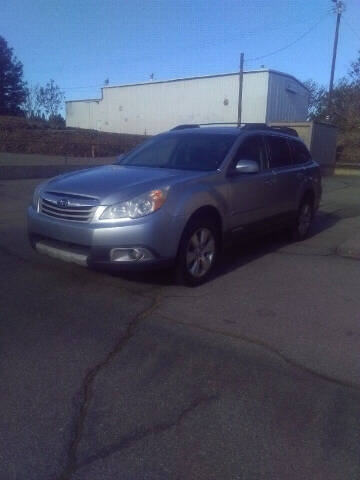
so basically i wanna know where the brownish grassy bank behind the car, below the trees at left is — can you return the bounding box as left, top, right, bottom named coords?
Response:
left=0, top=116, right=145, bottom=157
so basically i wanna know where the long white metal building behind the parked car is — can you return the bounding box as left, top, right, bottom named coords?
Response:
left=66, top=70, right=309, bottom=135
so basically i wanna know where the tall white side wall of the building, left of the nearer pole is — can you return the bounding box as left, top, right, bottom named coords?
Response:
left=103, top=76, right=237, bottom=135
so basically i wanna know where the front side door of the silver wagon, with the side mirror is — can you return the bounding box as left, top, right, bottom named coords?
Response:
left=228, top=134, right=276, bottom=231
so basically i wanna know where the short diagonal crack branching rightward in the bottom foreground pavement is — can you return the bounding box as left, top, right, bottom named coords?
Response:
left=77, top=395, right=218, bottom=469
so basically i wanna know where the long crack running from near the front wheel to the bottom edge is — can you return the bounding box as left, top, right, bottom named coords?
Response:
left=59, top=294, right=160, bottom=480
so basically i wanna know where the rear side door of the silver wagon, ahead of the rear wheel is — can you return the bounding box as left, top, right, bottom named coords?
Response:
left=265, top=134, right=303, bottom=222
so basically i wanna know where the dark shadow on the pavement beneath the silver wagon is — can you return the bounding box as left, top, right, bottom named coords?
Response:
left=97, top=211, right=342, bottom=288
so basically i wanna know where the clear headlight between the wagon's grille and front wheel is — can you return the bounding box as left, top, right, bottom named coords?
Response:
left=100, top=187, right=169, bottom=220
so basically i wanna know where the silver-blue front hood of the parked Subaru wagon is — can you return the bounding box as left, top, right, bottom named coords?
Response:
left=43, top=165, right=209, bottom=205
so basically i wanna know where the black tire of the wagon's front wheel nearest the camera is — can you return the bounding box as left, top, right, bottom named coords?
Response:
left=175, top=217, right=220, bottom=286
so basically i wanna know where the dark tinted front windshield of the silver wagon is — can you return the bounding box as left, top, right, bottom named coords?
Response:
left=118, top=133, right=236, bottom=171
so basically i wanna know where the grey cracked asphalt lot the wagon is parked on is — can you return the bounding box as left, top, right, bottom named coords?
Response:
left=0, top=177, right=360, bottom=480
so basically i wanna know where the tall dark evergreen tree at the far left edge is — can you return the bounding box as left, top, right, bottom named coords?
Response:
left=0, top=36, right=27, bottom=115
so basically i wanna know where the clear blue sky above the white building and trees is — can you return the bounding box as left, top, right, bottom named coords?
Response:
left=0, top=0, right=360, bottom=100
